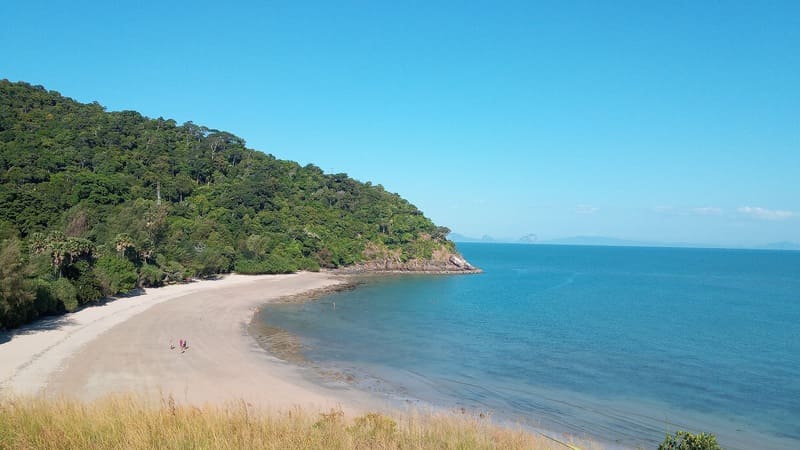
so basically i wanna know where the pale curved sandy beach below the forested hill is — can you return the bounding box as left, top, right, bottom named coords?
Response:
left=0, top=273, right=374, bottom=411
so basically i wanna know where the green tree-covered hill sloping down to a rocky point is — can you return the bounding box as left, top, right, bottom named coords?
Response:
left=0, top=80, right=472, bottom=328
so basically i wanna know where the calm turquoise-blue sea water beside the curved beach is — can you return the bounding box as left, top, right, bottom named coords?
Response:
left=259, top=244, right=800, bottom=449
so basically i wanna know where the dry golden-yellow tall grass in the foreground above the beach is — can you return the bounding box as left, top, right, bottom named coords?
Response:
left=0, top=396, right=588, bottom=450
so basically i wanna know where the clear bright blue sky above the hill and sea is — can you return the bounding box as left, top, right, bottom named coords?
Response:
left=0, top=0, right=800, bottom=246
